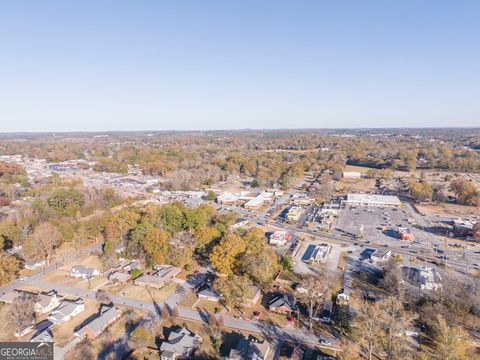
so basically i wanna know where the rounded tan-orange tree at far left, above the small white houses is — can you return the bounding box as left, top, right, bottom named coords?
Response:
left=25, top=222, right=63, bottom=264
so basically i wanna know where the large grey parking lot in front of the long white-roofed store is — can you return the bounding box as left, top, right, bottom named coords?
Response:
left=336, top=206, right=428, bottom=245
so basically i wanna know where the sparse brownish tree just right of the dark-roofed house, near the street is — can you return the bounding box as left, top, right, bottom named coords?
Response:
left=299, top=269, right=332, bottom=330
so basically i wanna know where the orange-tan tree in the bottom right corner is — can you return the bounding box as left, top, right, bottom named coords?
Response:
left=434, top=315, right=467, bottom=360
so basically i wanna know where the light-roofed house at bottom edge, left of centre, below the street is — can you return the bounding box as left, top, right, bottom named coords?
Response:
left=160, top=327, right=202, bottom=360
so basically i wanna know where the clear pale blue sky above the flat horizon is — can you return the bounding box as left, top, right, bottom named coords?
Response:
left=0, top=0, right=480, bottom=132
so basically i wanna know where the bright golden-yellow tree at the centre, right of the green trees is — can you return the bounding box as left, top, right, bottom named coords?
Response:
left=210, top=233, right=246, bottom=275
